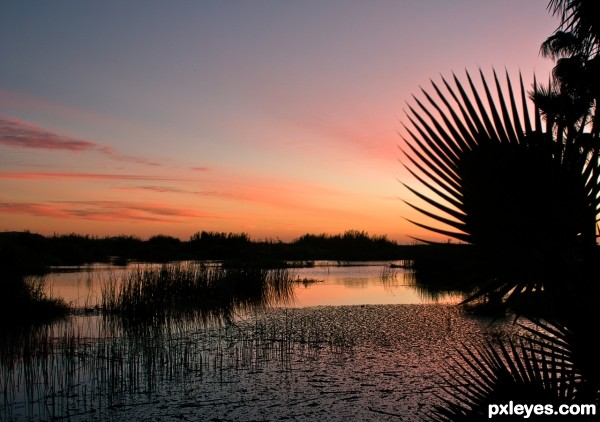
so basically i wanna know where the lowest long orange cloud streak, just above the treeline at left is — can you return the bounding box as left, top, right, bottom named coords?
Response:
left=0, top=201, right=222, bottom=223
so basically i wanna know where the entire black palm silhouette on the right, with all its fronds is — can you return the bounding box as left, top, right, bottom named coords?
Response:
left=402, top=0, right=600, bottom=421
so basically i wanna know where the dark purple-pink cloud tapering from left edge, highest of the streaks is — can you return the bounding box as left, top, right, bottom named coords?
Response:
left=0, top=116, right=162, bottom=166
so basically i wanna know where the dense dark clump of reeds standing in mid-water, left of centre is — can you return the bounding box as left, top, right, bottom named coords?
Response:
left=101, top=262, right=297, bottom=321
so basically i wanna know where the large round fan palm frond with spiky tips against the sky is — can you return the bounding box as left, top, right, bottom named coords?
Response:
left=401, top=71, right=598, bottom=306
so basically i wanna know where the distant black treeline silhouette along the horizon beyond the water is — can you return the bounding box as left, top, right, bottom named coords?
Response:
left=0, top=230, right=432, bottom=272
